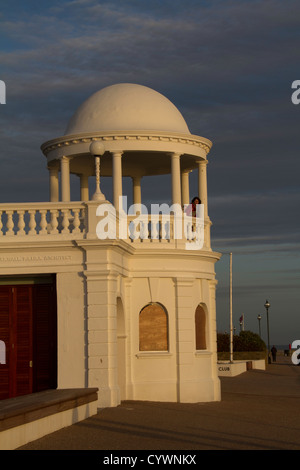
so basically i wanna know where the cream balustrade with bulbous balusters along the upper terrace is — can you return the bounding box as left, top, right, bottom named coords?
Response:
left=0, top=201, right=210, bottom=249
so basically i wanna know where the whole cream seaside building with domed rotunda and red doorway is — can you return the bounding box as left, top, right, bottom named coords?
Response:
left=0, top=84, right=220, bottom=407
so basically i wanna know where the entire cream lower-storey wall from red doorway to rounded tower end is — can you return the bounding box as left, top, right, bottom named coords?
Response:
left=2, top=240, right=220, bottom=406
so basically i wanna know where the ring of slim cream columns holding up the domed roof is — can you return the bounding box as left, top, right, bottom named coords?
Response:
left=49, top=152, right=208, bottom=216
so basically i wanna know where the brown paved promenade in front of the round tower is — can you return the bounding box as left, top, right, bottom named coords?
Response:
left=21, top=356, right=300, bottom=451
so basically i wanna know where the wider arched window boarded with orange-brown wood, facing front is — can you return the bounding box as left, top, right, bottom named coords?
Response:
left=139, top=303, right=169, bottom=351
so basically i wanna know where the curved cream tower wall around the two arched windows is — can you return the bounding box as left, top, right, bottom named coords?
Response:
left=128, top=266, right=220, bottom=402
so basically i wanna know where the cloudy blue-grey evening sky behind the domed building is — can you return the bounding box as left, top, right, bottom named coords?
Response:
left=0, top=0, right=300, bottom=345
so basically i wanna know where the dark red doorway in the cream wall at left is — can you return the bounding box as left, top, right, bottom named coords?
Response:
left=0, top=276, right=57, bottom=400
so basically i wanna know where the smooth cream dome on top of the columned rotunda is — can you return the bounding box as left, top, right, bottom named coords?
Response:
left=65, top=83, right=190, bottom=135
